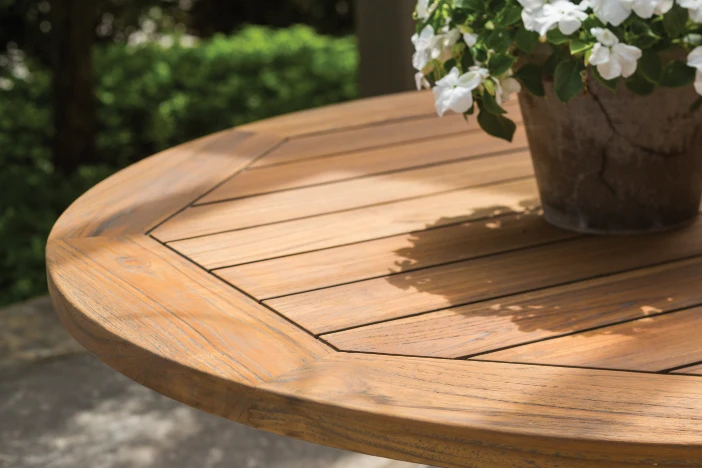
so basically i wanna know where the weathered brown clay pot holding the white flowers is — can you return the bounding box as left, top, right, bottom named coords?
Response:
left=520, top=77, right=702, bottom=234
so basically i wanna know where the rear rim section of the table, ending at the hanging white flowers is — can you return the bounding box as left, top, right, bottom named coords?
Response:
left=238, top=91, right=436, bottom=137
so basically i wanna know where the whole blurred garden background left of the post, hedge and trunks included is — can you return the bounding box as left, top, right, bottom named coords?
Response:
left=0, top=0, right=358, bottom=305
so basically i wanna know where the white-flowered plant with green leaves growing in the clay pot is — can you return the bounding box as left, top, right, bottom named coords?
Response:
left=412, top=0, right=702, bottom=141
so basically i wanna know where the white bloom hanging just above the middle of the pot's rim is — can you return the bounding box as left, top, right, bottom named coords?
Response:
left=590, top=28, right=642, bottom=80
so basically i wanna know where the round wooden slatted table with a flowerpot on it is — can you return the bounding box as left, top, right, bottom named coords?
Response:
left=47, top=93, right=702, bottom=468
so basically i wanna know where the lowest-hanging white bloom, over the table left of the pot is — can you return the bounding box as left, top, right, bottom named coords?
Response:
left=433, top=67, right=488, bottom=116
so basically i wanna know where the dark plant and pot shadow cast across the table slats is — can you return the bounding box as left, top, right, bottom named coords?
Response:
left=381, top=210, right=702, bottom=367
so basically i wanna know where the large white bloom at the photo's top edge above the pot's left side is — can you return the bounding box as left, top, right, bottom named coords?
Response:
left=519, top=0, right=589, bottom=36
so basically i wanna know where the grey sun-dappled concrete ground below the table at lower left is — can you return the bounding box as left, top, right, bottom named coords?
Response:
left=0, top=298, right=428, bottom=468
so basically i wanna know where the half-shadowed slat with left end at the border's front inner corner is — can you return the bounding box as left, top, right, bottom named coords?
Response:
left=324, top=259, right=702, bottom=358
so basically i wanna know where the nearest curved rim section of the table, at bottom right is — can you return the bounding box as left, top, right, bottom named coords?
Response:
left=245, top=354, right=702, bottom=468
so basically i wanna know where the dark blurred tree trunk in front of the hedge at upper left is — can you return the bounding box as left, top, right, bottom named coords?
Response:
left=51, top=0, right=98, bottom=174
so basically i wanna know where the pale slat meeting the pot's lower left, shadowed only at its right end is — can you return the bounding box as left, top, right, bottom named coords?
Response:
left=170, top=179, right=538, bottom=269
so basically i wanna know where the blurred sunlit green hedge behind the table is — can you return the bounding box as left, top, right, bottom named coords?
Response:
left=0, top=26, right=357, bottom=304
